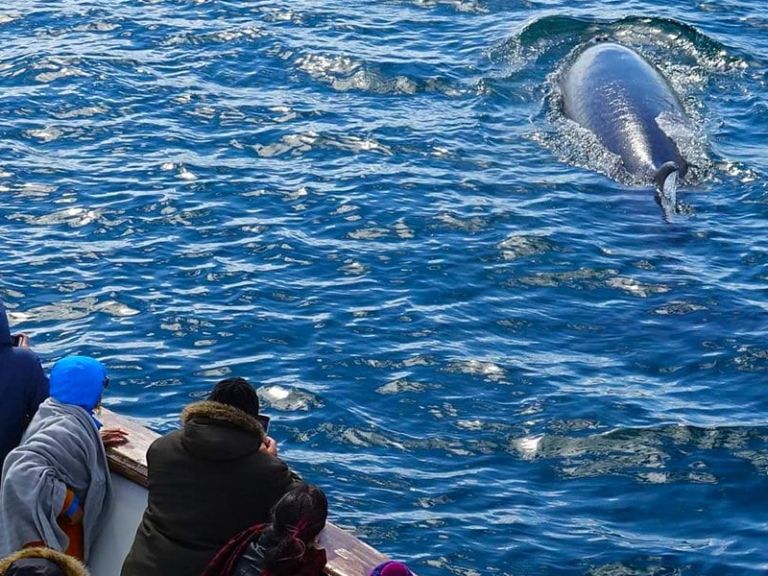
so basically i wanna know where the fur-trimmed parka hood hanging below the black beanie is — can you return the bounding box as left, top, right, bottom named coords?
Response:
left=181, top=400, right=265, bottom=460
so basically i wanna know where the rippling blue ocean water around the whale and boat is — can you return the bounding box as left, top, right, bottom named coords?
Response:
left=0, top=0, right=768, bottom=576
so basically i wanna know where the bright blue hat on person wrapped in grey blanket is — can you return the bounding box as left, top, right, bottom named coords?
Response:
left=50, top=356, right=108, bottom=412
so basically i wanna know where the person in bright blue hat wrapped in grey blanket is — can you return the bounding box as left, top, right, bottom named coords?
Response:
left=0, top=356, right=126, bottom=560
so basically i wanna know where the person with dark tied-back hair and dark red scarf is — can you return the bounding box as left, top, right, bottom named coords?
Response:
left=201, top=484, right=328, bottom=576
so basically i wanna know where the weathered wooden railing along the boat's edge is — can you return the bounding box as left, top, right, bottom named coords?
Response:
left=100, top=409, right=387, bottom=576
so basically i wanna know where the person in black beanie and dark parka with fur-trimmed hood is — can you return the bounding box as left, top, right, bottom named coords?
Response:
left=121, top=378, right=301, bottom=576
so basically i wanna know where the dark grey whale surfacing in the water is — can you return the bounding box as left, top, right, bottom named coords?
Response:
left=559, top=37, right=690, bottom=216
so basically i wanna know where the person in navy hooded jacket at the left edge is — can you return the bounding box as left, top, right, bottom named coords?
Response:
left=0, top=301, right=48, bottom=467
